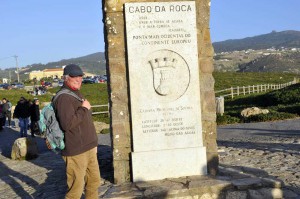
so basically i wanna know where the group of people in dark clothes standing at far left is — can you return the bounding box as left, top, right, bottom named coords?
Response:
left=0, top=97, right=40, bottom=137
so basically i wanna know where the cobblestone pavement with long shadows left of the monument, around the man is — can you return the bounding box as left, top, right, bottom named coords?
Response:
left=0, top=128, right=112, bottom=199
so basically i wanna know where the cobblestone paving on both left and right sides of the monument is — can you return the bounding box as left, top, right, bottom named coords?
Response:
left=0, top=119, right=300, bottom=199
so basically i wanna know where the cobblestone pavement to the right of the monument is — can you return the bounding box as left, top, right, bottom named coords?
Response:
left=218, top=119, right=300, bottom=195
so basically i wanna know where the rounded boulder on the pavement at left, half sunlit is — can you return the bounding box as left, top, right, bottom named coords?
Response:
left=11, top=138, right=38, bottom=160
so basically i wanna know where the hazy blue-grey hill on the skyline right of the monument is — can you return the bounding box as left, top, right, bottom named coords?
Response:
left=213, top=30, right=300, bottom=53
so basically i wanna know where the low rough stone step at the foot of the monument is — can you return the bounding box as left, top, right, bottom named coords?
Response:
left=101, top=167, right=298, bottom=199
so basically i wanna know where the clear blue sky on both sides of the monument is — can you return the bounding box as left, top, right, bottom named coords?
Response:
left=0, top=0, right=300, bottom=69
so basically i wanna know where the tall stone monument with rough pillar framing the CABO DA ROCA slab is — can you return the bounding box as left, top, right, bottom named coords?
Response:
left=104, top=0, right=218, bottom=184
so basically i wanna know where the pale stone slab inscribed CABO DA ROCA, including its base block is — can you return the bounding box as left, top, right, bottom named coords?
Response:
left=125, top=1, right=206, bottom=181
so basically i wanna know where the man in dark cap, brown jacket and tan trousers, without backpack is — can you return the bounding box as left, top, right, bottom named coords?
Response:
left=54, top=64, right=101, bottom=199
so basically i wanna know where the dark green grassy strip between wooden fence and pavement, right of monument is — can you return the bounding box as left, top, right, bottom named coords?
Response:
left=217, top=83, right=300, bottom=124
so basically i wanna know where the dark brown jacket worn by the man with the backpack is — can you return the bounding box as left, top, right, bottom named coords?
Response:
left=54, top=85, right=98, bottom=156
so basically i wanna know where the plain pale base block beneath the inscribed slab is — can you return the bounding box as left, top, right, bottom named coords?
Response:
left=131, top=147, right=207, bottom=182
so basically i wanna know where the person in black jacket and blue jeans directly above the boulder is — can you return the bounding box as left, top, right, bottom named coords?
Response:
left=13, top=97, right=30, bottom=137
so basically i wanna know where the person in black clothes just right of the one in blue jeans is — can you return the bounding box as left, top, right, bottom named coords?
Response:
left=29, top=98, right=40, bottom=137
